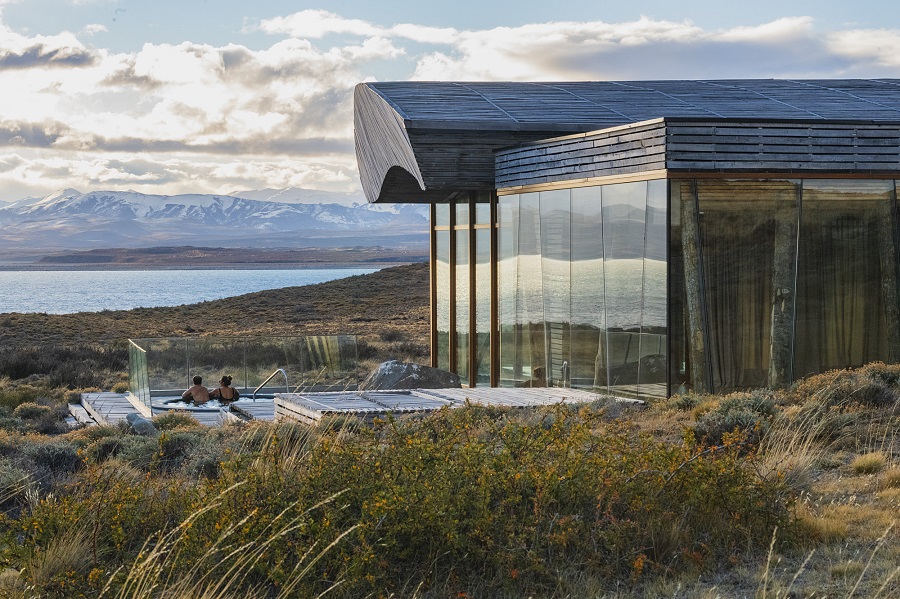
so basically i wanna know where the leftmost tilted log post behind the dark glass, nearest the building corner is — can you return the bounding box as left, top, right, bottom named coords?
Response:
left=681, top=182, right=713, bottom=393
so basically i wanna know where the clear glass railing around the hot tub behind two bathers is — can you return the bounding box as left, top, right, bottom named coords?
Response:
left=129, top=335, right=364, bottom=404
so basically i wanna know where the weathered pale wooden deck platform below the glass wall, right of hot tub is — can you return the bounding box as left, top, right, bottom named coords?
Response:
left=275, top=387, right=628, bottom=424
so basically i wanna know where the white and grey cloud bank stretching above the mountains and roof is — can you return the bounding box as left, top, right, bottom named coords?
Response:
left=0, top=9, right=900, bottom=199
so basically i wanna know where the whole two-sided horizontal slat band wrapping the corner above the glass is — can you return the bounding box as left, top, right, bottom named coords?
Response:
left=495, top=119, right=900, bottom=189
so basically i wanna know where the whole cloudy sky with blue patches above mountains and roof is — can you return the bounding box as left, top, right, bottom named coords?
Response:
left=0, top=0, right=900, bottom=201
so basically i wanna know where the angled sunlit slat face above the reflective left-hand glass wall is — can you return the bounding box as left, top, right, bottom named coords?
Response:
left=496, top=121, right=665, bottom=189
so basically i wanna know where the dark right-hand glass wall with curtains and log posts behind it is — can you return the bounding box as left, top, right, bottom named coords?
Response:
left=669, top=179, right=900, bottom=393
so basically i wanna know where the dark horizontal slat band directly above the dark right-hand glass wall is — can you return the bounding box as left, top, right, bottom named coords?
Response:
left=666, top=119, right=900, bottom=173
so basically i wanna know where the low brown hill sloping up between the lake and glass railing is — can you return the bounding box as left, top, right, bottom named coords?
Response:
left=0, top=263, right=429, bottom=350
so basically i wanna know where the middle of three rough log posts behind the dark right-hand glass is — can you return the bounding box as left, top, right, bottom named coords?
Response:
left=768, top=191, right=798, bottom=389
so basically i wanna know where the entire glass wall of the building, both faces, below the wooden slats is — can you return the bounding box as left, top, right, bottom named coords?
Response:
left=432, top=178, right=900, bottom=397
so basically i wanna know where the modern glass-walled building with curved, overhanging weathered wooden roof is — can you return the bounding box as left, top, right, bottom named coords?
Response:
left=355, top=80, right=900, bottom=396
